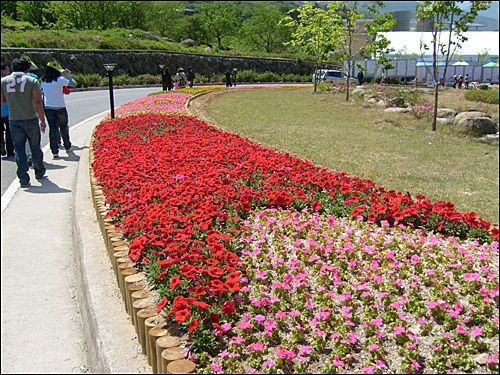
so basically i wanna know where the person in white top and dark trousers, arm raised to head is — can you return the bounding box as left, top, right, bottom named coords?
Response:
left=42, top=61, right=76, bottom=159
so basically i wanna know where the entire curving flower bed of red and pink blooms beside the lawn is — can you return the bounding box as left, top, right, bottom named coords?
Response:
left=93, top=88, right=499, bottom=373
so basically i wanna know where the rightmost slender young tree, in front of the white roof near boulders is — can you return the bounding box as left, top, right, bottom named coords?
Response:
left=417, top=1, right=491, bottom=131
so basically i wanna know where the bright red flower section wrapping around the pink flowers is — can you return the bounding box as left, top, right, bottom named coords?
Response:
left=93, top=115, right=498, bottom=332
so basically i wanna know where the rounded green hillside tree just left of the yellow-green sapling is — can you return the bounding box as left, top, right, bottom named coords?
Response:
left=241, top=8, right=290, bottom=53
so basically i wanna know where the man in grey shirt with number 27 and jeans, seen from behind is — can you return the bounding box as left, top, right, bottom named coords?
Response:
left=1, top=58, right=47, bottom=188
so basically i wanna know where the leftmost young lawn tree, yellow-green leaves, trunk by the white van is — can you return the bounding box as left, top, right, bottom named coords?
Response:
left=280, top=1, right=341, bottom=92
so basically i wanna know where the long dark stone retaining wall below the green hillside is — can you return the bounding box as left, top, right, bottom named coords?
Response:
left=2, top=47, right=314, bottom=77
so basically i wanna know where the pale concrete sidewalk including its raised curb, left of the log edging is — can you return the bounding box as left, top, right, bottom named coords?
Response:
left=1, top=115, right=151, bottom=374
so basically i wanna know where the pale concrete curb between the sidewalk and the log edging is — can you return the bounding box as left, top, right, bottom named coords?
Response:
left=71, top=119, right=151, bottom=373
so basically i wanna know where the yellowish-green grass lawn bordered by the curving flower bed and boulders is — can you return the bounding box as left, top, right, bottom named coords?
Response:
left=199, top=88, right=499, bottom=224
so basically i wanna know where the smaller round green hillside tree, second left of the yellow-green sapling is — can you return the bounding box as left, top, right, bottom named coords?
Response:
left=201, top=3, right=240, bottom=48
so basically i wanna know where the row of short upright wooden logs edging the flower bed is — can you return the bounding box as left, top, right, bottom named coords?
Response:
left=89, top=129, right=196, bottom=374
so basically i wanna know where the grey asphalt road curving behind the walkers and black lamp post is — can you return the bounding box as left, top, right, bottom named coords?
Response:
left=1, top=87, right=161, bottom=195
